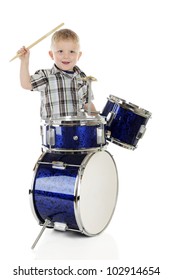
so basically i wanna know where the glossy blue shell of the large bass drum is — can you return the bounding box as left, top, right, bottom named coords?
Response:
left=33, top=153, right=85, bottom=229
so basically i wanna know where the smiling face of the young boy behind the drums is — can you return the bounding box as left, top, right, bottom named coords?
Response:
left=49, top=40, right=82, bottom=71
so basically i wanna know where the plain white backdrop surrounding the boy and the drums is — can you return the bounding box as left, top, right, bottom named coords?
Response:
left=0, top=0, right=173, bottom=279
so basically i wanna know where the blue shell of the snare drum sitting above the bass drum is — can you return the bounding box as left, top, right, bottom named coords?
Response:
left=42, top=124, right=106, bottom=150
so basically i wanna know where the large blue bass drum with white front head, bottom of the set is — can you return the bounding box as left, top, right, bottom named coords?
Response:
left=30, top=150, right=118, bottom=236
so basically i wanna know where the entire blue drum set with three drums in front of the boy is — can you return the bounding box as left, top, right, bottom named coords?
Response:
left=29, top=81, right=151, bottom=249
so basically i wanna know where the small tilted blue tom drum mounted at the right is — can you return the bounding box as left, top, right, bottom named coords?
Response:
left=102, top=95, right=151, bottom=150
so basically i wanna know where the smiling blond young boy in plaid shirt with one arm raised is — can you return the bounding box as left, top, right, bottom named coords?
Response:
left=18, top=29, right=96, bottom=120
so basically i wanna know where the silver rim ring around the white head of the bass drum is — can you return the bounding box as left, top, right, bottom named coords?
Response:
left=74, top=150, right=119, bottom=236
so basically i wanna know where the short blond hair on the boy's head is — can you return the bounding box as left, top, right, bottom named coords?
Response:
left=51, top=29, right=80, bottom=47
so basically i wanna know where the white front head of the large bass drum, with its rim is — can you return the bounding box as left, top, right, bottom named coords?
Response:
left=76, top=151, right=118, bottom=236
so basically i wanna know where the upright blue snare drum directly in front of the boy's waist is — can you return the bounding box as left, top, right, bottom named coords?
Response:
left=41, top=116, right=106, bottom=151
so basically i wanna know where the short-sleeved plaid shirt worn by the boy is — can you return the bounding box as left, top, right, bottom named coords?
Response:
left=31, top=65, right=93, bottom=120
